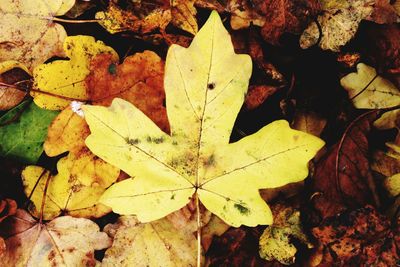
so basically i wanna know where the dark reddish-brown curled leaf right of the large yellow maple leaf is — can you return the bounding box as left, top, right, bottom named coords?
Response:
left=312, top=111, right=379, bottom=218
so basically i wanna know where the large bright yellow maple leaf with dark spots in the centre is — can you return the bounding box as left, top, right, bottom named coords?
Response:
left=83, top=12, right=323, bottom=226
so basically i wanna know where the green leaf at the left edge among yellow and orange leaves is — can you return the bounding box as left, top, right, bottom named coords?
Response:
left=0, top=102, right=58, bottom=164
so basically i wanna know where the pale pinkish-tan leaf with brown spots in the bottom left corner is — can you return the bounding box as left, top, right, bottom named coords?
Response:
left=0, top=210, right=111, bottom=267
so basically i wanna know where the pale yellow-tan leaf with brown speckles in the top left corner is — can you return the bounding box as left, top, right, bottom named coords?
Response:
left=0, top=0, right=75, bottom=71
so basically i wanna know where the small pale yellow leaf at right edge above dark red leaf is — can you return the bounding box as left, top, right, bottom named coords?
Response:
left=340, top=63, right=400, bottom=109
